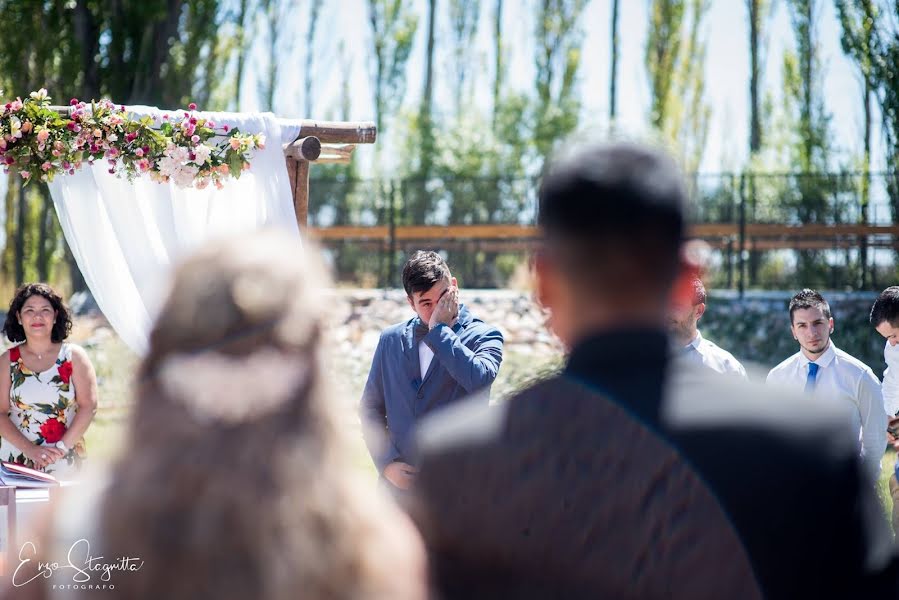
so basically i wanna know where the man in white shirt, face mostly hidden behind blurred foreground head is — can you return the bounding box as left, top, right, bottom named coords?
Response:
left=668, top=277, right=746, bottom=377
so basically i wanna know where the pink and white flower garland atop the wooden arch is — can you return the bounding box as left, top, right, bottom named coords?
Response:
left=0, top=88, right=265, bottom=189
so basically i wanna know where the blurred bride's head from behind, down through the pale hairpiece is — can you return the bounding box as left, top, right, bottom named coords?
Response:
left=137, top=231, right=331, bottom=438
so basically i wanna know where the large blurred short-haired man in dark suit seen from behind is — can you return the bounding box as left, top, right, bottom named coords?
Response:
left=414, top=145, right=888, bottom=598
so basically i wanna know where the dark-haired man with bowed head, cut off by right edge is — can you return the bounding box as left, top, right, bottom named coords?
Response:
left=871, top=285, right=899, bottom=533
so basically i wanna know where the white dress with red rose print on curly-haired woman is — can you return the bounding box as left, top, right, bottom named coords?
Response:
left=0, top=343, right=84, bottom=476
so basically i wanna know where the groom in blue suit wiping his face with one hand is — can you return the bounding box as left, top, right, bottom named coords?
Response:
left=359, top=250, right=503, bottom=490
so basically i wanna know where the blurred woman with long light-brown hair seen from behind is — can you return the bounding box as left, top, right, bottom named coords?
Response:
left=0, top=232, right=427, bottom=600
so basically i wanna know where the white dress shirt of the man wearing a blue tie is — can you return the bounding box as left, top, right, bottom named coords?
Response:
left=768, top=340, right=887, bottom=480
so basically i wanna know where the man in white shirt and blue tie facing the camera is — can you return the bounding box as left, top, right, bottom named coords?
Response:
left=768, top=289, right=887, bottom=481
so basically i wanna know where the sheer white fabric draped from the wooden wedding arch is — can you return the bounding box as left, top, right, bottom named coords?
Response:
left=50, top=107, right=299, bottom=354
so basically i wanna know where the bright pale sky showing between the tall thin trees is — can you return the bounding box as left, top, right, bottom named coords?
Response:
left=253, top=0, right=883, bottom=173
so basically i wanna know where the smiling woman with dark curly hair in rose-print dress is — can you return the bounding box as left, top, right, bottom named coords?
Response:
left=0, top=283, right=97, bottom=478
